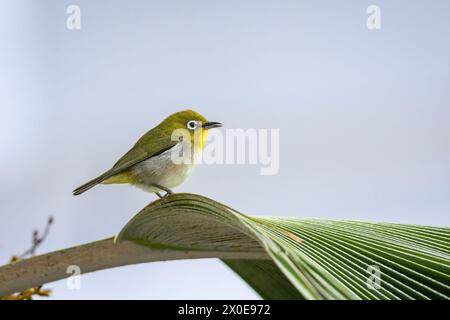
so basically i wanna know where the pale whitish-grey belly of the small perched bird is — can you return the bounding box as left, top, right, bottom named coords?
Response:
left=133, top=143, right=194, bottom=192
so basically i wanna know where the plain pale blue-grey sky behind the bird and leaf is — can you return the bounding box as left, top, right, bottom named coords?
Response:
left=0, top=0, right=450, bottom=299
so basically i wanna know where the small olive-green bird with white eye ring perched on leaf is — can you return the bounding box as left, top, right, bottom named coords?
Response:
left=73, top=110, right=222, bottom=198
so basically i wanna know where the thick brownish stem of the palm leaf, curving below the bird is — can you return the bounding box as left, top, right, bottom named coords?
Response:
left=0, top=238, right=269, bottom=296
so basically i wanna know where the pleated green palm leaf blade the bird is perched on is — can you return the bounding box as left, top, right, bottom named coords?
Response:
left=117, top=194, right=450, bottom=299
